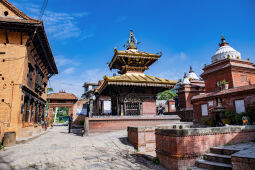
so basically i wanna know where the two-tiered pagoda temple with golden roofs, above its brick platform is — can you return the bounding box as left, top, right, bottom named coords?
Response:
left=94, top=30, right=176, bottom=116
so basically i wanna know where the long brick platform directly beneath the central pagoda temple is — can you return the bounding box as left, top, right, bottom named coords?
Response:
left=89, top=115, right=180, bottom=133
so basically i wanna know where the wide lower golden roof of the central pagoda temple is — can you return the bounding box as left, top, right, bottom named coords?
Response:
left=96, top=73, right=176, bottom=93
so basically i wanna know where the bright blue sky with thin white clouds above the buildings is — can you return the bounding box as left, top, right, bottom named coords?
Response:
left=10, top=0, right=255, bottom=97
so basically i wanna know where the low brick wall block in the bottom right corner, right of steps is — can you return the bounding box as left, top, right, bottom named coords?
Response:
left=231, top=148, right=255, bottom=170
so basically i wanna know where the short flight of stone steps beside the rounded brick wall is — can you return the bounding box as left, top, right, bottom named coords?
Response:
left=191, top=147, right=240, bottom=170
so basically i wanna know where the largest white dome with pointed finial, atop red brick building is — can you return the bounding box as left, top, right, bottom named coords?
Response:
left=212, top=37, right=241, bottom=63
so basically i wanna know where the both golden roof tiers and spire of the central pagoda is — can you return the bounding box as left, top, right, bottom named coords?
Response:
left=96, top=30, right=176, bottom=94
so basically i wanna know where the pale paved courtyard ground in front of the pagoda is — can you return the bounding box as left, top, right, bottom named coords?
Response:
left=0, top=126, right=163, bottom=170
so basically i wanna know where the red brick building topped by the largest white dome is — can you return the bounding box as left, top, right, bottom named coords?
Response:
left=192, top=36, right=255, bottom=122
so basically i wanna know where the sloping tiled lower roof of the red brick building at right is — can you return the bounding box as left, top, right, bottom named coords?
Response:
left=191, top=84, right=255, bottom=101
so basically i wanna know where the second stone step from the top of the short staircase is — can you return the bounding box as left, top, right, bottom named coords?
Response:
left=203, top=153, right=231, bottom=164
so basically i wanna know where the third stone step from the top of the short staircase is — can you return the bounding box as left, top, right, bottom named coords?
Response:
left=195, top=159, right=232, bottom=170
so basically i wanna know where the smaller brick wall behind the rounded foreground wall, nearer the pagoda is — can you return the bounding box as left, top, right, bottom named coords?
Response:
left=127, top=122, right=193, bottom=152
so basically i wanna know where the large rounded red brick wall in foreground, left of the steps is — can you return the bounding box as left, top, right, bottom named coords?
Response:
left=156, top=126, right=255, bottom=170
